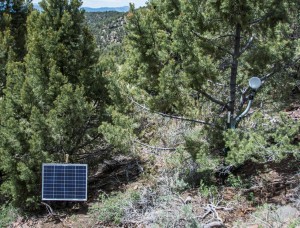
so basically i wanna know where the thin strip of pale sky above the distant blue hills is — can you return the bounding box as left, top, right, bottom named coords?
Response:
left=32, top=0, right=147, bottom=8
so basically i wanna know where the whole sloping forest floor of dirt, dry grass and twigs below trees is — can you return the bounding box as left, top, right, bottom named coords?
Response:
left=10, top=108, right=300, bottom=228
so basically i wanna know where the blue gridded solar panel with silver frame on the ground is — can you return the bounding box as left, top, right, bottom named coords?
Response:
left=42, top=163, right=87, bottom=201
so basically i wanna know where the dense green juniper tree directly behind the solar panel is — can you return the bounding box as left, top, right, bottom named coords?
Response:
left=0, top=0, right=107, bottom=209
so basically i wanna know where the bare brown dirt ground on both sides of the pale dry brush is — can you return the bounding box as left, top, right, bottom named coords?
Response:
left=11, top=158, right=300, bottom=228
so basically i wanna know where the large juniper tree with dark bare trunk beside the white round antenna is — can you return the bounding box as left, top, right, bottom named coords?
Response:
left=113, top=0, right=300, bottom=168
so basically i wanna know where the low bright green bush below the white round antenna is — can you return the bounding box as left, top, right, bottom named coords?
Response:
left=224, top=113, right=300, bottom=165
